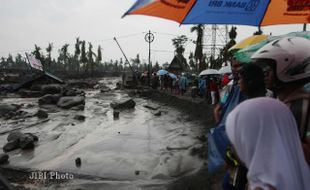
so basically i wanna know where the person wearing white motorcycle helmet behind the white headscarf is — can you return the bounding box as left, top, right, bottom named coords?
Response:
left=251, top=37, right=310, bottom=166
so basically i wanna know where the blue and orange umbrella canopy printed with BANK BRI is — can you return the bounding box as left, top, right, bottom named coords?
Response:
left=123, top=0, right=310, bottom=26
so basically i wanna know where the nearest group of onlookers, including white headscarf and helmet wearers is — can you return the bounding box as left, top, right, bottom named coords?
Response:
left=208, top=37, right=310, bottom=190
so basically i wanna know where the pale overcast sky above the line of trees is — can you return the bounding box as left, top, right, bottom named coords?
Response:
left=0, top=0, right=302, bottom=64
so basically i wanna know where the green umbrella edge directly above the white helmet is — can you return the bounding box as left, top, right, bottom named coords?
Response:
left=234, top=31, right=310, bottom=63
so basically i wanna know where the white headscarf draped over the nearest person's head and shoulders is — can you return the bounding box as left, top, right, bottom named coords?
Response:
left=226, top=97, right=310, bottom=190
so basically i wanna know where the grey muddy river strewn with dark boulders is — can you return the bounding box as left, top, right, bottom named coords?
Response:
left=0, top=78, right=205, bottom=190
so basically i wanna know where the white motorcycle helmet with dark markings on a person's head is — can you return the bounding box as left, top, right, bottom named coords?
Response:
left=251, top=37, right=310, bottom=83
